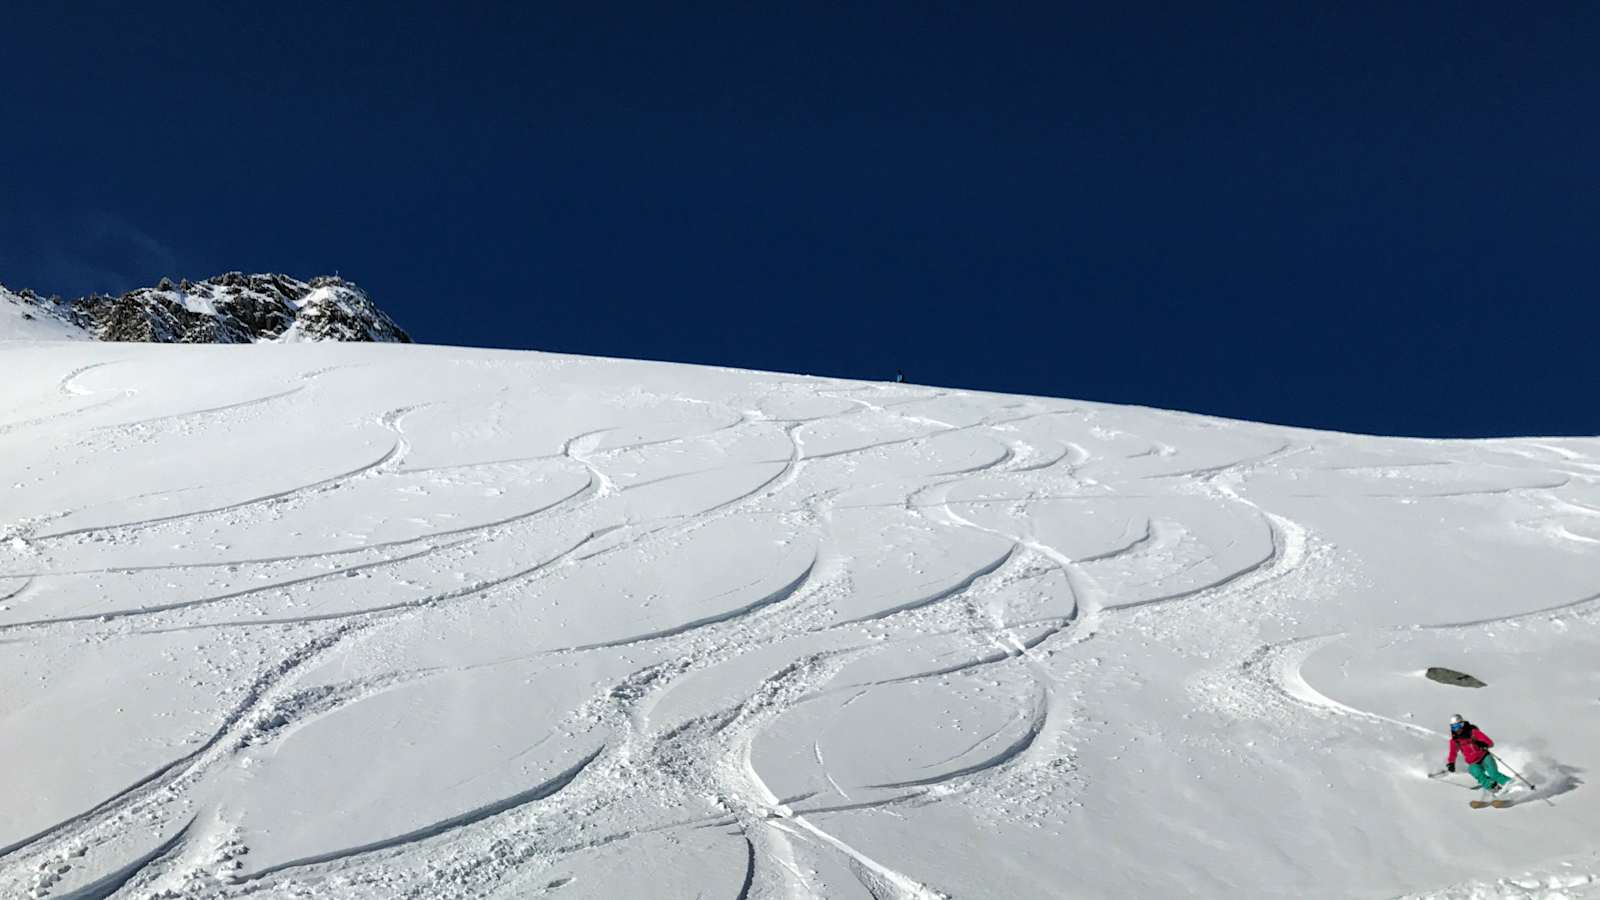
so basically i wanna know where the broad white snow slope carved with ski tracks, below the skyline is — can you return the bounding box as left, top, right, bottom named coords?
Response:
left=0, top=343, right=1600, bottom=900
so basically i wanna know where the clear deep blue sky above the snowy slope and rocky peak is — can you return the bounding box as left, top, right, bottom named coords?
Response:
left=0, top=3, right=1600, bottom=436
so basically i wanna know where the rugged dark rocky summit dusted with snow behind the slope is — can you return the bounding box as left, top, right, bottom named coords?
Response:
left=0, top=272, right=411, bottom=344
